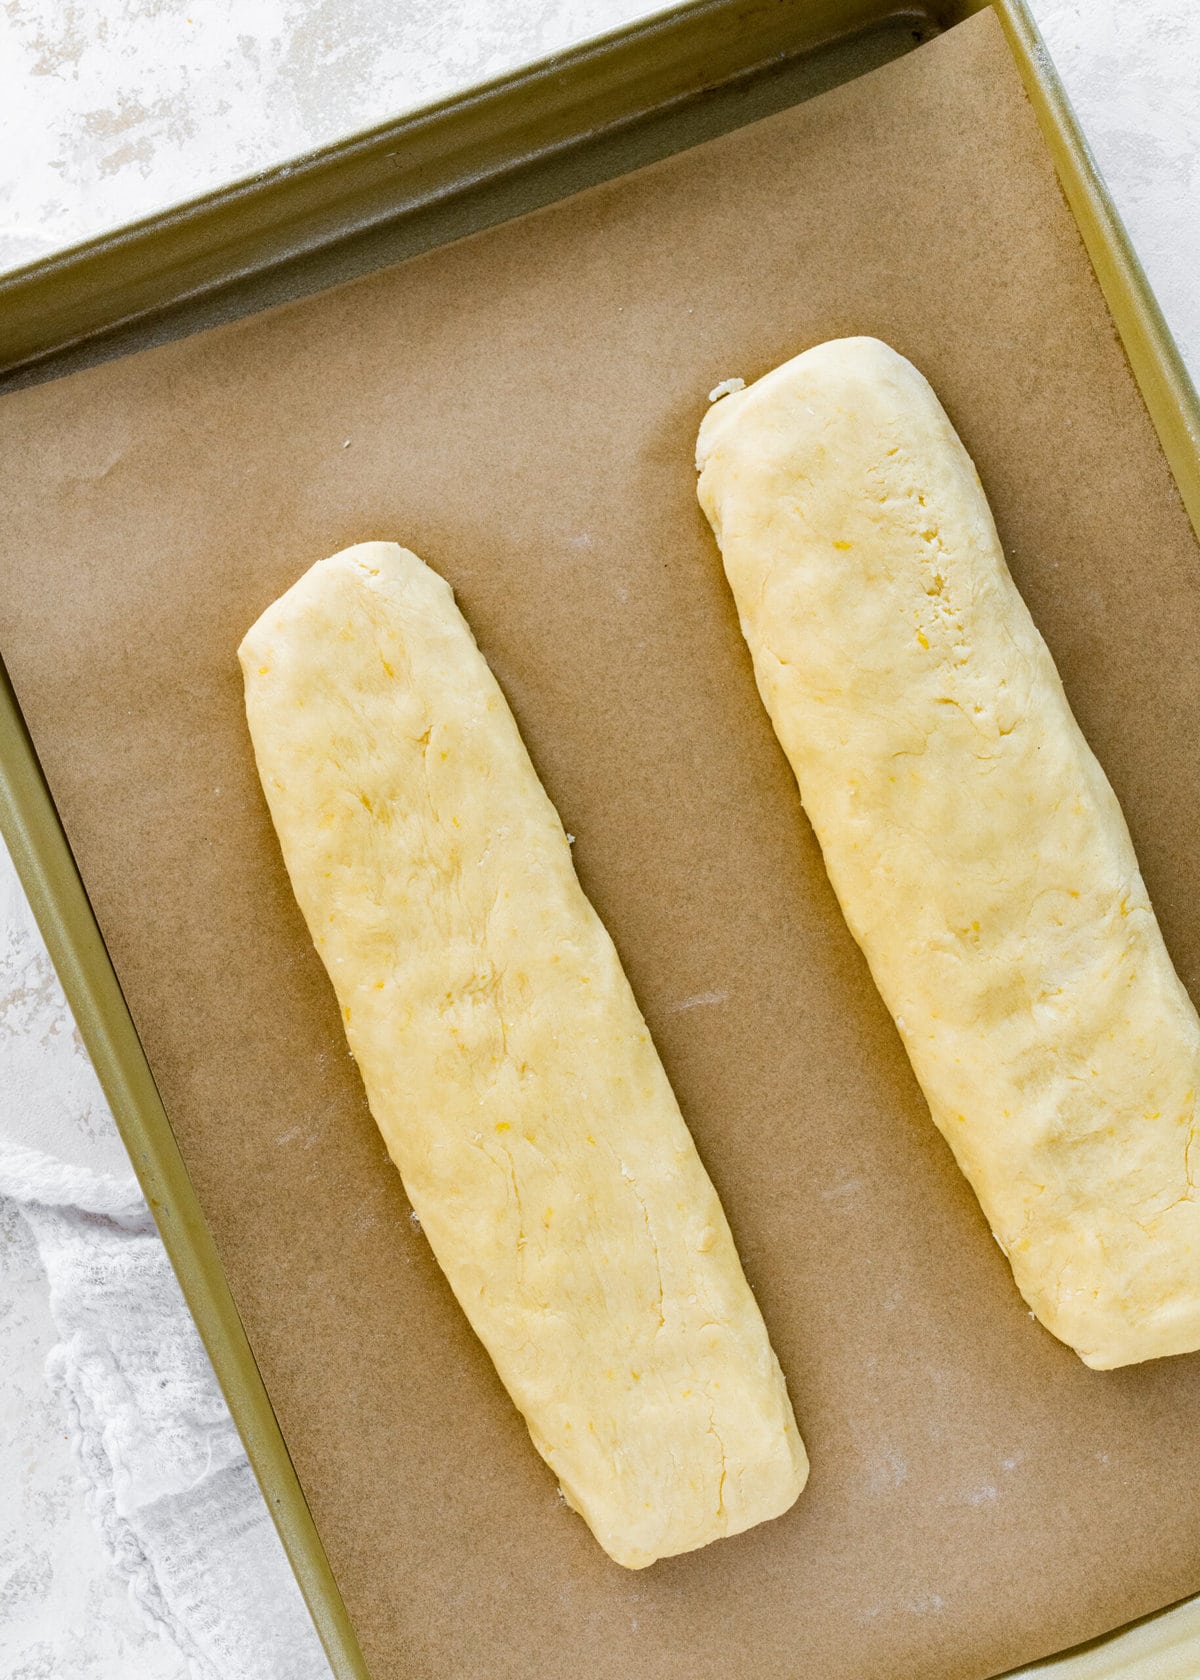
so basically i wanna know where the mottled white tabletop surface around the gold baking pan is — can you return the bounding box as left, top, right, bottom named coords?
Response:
left=0, top=0, right=1200, bottom=1680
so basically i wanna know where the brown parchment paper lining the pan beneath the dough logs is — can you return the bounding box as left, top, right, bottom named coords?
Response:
left=0, top=15, right=1200, bottom=1680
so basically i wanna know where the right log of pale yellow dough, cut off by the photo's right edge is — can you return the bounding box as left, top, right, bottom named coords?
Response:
left=697, top=338, right=1200, bottom=1369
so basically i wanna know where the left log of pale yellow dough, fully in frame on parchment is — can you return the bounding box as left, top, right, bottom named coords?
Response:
left=239, top=543, right=808, bottom=1569
